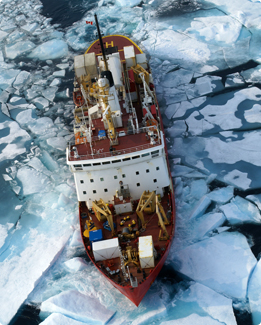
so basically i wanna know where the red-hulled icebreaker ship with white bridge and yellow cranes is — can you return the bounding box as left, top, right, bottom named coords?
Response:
left=67, top=16, right=175, bottom=305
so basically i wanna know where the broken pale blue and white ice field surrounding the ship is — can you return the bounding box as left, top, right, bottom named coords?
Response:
left=0, top=0, right=261, bottom=325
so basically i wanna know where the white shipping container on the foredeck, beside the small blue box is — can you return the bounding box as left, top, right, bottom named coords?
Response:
left=92, top=238, right=120, bottom=262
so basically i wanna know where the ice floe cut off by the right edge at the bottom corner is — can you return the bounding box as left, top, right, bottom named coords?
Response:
left=248, top=260, right=261, bottom=325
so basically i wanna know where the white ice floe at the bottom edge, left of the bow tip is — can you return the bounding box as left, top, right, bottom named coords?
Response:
left=41, top=290, right=115, bottom=324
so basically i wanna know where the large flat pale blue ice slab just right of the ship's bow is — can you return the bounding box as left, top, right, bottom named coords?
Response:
left=171, top=232, right=256, bottom=300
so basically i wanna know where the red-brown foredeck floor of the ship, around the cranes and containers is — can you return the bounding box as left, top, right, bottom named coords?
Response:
left=80, top=187, right=174, bottom=287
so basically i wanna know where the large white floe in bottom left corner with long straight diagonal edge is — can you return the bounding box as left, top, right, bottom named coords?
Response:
left=0, top=227, right=71, bottom=325
